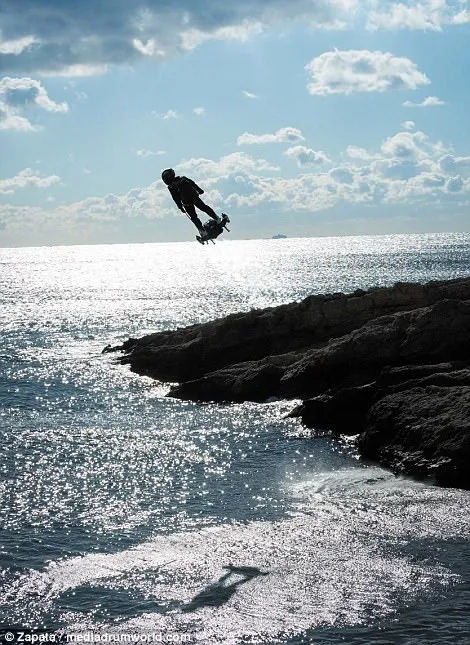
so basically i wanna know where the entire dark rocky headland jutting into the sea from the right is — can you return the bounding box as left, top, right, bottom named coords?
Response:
left=106, top=278, right=470, bottom=487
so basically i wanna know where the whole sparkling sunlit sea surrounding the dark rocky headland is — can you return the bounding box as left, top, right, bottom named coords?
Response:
left=0, top=233, right=470, bottom=645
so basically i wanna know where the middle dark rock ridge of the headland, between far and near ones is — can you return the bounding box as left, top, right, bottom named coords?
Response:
left=170, top=300, right=470, bottom=401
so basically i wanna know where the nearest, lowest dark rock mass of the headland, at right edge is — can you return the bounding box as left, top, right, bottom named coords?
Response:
left=291, top=361, right=470, bottom=488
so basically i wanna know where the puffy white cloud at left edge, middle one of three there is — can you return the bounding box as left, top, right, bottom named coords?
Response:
left=0, top=76, right=69, bottom=132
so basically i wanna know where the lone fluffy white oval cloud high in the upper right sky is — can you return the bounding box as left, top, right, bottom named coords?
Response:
left=305, top=49, right=430, bottom=96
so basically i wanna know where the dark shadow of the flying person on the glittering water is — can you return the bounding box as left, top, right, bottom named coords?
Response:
left=181, top=564, right=268, bottom=613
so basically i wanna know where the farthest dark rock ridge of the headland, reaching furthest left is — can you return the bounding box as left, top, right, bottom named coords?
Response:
left=111, top=279, right=470, bottom=382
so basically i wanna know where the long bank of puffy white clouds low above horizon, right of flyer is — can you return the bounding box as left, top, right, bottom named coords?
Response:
left=226, top=126, right=470, bottom=213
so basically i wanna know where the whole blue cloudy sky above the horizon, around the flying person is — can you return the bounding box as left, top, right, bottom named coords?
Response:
left=0, top=0, right=470, bottom=247
